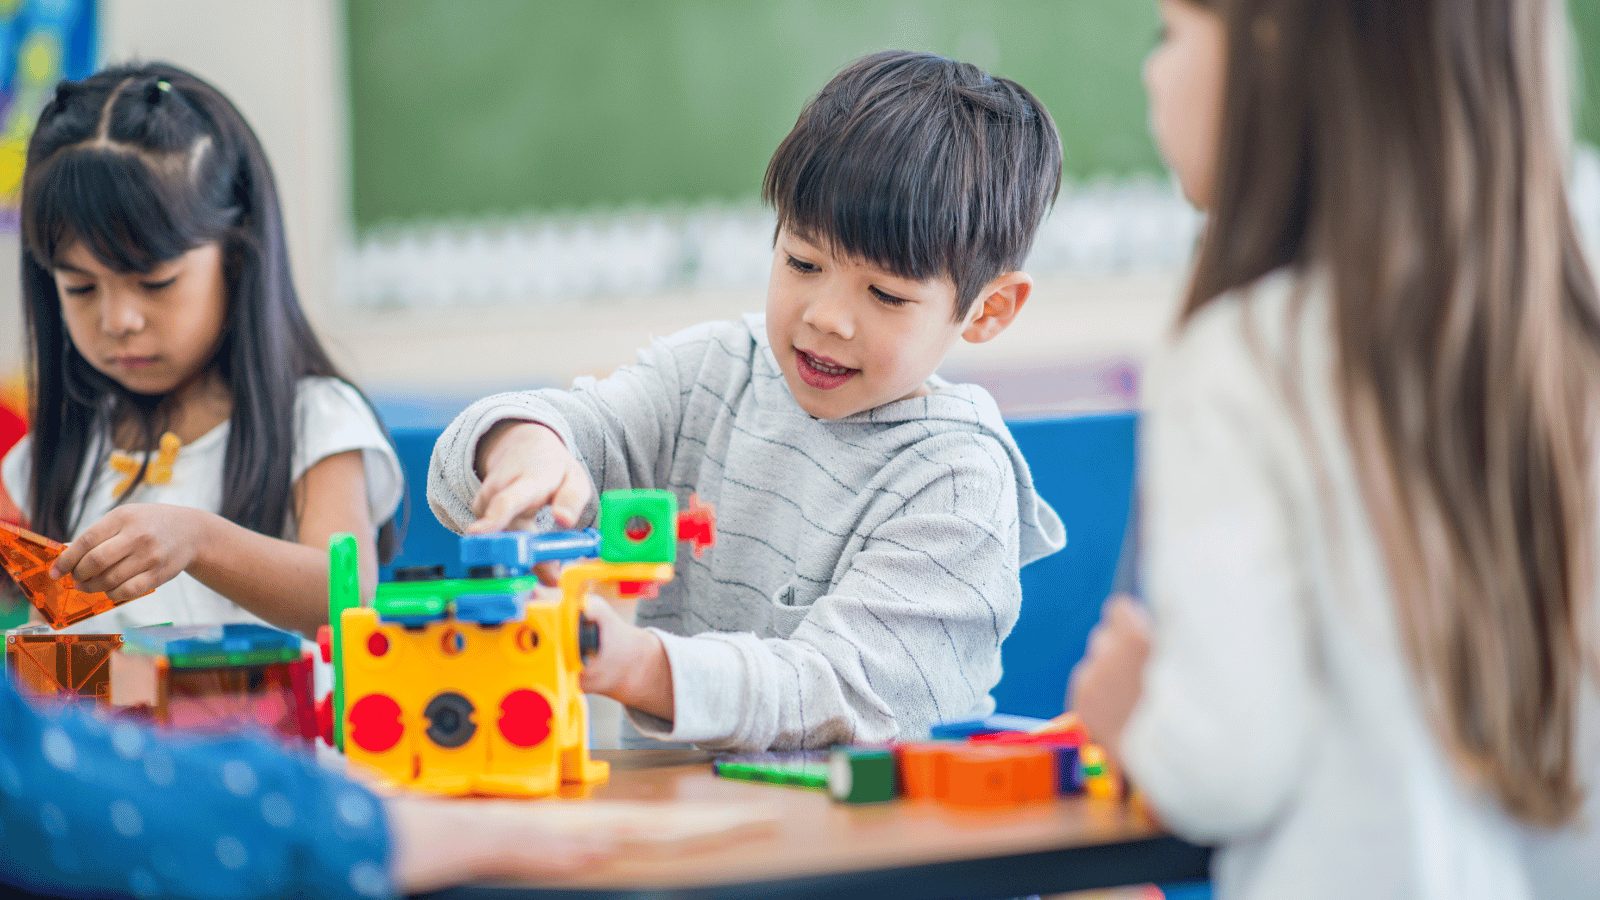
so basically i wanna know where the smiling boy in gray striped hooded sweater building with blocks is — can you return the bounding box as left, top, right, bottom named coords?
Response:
left=427, top=51, right=1066, bottom=749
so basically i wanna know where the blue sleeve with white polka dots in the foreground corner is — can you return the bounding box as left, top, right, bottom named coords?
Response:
left=0, top=679, right=394, bottom=898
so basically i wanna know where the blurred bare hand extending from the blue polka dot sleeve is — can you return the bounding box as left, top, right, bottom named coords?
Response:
left=386, top=794, right=613, bottom=894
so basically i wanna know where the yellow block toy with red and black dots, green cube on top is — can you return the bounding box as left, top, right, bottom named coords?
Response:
left=318, top=490, right=715, bottom=798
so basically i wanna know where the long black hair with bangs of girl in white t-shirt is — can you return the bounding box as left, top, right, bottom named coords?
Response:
left=21, top=62, right=398, bottom=559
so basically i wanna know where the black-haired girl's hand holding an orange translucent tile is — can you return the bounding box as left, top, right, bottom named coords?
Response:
left=50, top=503, right=211, bottom=601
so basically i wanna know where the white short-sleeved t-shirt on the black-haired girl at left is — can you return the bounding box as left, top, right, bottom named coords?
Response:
left=0, top=378, right=405, bottom=633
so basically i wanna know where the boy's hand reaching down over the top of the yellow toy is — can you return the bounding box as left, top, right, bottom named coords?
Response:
left=467, top=421, right=595, bottom=535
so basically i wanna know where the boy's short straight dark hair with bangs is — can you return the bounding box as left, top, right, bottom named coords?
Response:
left=762, top=50, right=1061, bottom=319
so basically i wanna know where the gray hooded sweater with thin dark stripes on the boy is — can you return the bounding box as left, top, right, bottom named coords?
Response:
left=427, top=315, right=1066, bottom=749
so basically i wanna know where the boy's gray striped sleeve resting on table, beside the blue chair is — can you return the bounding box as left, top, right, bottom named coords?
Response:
left=629, top=434, right=1021, bottom=749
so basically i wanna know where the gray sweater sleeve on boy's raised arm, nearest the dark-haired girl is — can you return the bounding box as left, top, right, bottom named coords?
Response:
left=427, top=325, right=723, bottom=532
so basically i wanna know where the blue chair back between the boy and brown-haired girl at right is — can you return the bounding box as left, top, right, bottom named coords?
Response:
left=995, top=413, right=1138, bottom=717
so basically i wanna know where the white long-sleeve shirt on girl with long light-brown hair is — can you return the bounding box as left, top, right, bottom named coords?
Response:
left=1123, top=274, right=1600, bottom=900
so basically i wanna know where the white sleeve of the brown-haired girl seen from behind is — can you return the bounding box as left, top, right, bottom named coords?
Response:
left=1123, top=301, right=1322, bottom=841
